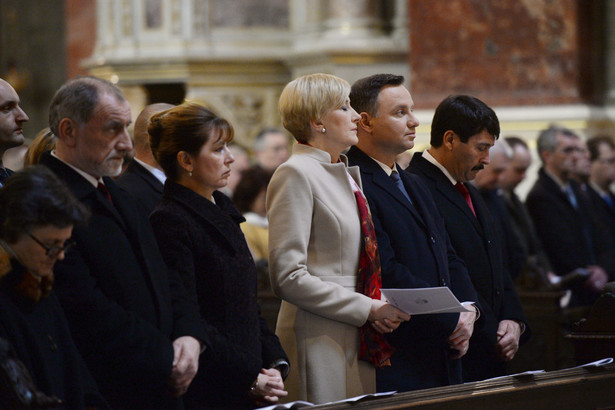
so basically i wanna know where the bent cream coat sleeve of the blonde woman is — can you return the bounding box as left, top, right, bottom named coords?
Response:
left=267, top=163, right=372, bottom=327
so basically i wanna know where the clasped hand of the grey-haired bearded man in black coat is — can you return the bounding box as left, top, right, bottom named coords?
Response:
left=168, top=336, right=201, bottom=397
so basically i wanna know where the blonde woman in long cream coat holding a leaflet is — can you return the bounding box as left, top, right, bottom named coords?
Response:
left=267, top=74, right=409, bottom=403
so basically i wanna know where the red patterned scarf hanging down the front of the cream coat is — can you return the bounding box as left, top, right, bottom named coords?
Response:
left=354, top=187, right=394, bottom=367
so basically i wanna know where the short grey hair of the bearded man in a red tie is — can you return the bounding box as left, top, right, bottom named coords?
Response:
left=49, top=76, right=126, bottom=136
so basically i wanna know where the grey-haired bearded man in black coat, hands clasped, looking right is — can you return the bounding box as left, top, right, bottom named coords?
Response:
left=41, top=77, right=207, bottom=408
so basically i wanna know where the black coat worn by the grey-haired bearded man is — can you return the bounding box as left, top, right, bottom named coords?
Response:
left=41, top=153, right=207, bottom=408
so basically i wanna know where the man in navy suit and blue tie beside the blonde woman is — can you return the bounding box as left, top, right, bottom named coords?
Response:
left=347, top=74, right=478, bottom=391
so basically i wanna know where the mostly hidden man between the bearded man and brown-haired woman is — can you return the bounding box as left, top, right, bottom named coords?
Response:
left=117, top=103, right=173, bottom=216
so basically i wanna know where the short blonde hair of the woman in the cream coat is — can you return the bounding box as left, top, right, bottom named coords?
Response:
left=279, top=73, right=350, bottom=143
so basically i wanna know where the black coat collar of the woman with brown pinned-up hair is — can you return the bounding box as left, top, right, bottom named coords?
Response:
left=163, top=179, right=245, bottom=252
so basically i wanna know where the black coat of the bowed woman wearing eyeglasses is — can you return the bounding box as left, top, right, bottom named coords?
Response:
left=0, top=260, right=107, bottom=409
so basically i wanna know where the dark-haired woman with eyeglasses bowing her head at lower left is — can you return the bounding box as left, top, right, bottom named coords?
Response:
left=0, top=166, right=108, bottom=409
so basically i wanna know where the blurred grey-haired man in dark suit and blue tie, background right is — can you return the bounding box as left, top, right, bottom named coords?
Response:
left=526, top=126, right=608, bottom=306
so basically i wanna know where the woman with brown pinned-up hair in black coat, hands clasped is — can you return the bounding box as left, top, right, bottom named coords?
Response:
left=148, top=104, right=288, bottom=408
